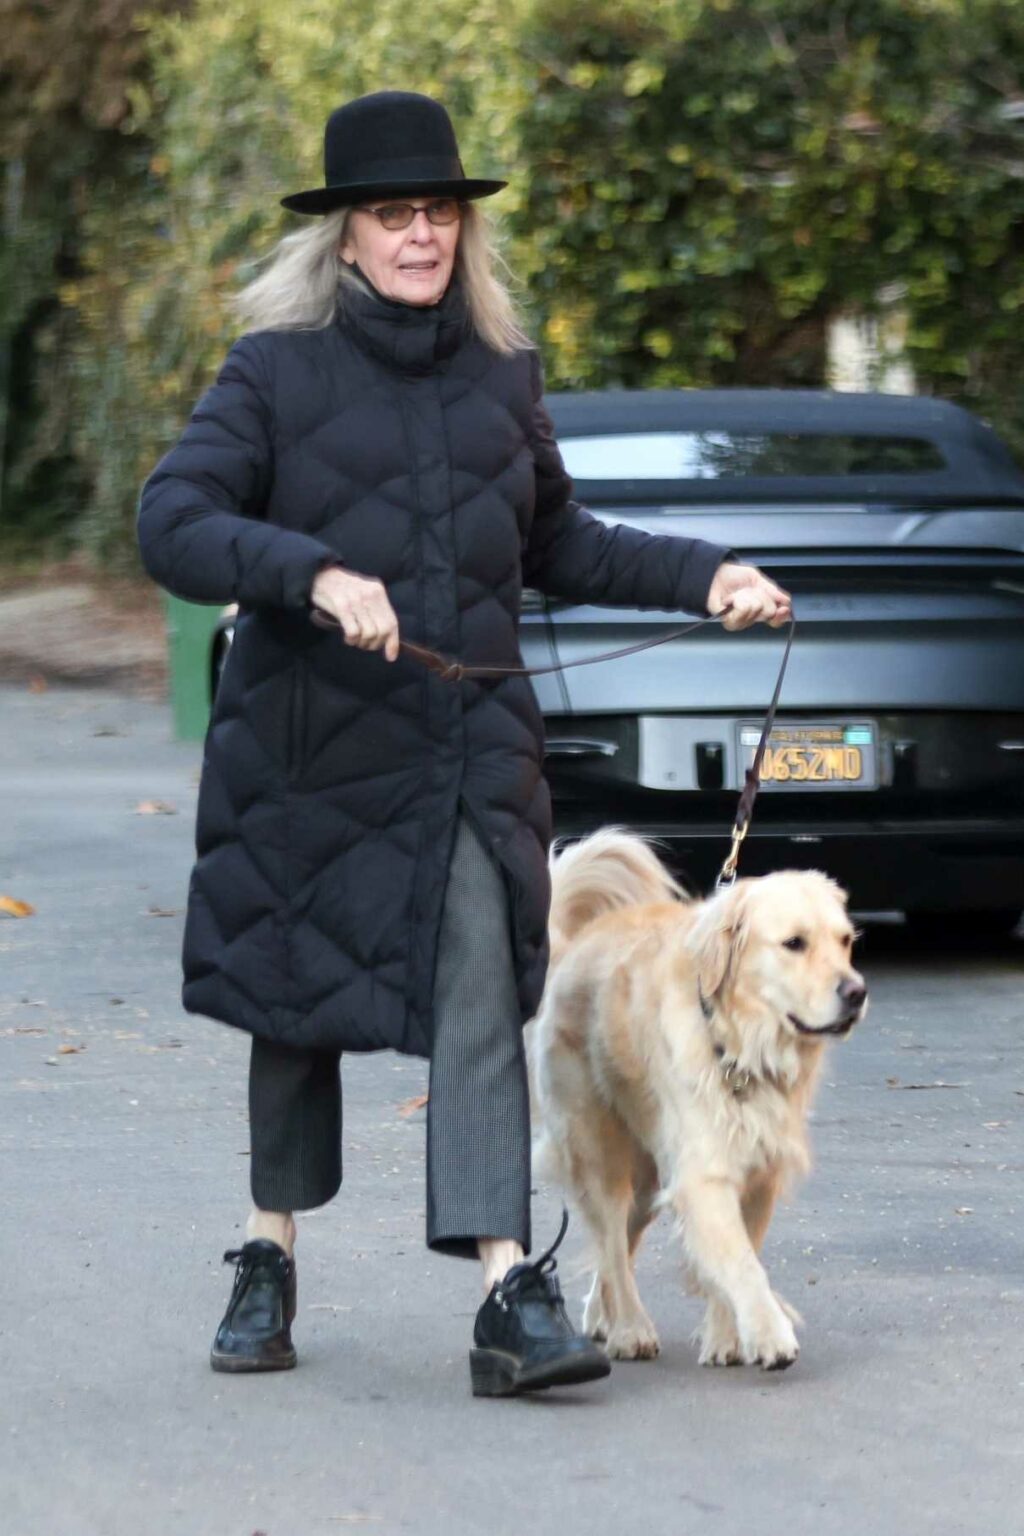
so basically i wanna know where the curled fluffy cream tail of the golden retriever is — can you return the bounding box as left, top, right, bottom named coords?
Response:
left=550, top=826, right=691, bottom=966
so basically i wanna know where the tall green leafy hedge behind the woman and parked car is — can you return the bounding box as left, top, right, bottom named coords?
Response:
left=0, top=0, right=1024, bottom=565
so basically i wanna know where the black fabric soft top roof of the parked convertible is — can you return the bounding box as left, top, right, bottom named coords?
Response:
left=547, top=389, right=1024, bottom=507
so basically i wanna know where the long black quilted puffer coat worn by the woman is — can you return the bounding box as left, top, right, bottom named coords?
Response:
left=138, top=287, right=725, bottom=1055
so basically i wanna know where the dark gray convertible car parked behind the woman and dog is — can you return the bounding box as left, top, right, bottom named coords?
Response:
left=211, top=390, right=1024, bottom=932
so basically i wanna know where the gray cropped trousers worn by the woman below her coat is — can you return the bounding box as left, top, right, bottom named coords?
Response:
left=249, top=816, right=530, bottom=1258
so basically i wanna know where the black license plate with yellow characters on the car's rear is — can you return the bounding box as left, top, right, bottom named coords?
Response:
left=737, top=720, right=878, bottom=790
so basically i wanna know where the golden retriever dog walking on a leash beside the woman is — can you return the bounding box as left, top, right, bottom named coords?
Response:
left=530, top=828, right=867, bottom=1370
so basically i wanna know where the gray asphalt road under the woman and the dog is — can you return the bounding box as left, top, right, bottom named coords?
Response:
left=0, top=688, right=1024, bottom=1536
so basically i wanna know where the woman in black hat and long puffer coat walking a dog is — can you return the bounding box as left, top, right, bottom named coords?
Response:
left=138, top=92, right=789, bottom=1395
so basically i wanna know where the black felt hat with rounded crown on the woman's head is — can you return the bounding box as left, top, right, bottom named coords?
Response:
left=281, top=91, right=508, bottom=214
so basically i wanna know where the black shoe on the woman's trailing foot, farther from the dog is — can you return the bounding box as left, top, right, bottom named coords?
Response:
left=210, top=1238, right=296, bottom=1372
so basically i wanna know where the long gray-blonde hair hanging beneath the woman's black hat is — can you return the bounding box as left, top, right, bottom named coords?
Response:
left=229, top=203, right=533, bottom=356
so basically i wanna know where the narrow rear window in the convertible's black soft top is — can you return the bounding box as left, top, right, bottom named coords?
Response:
left=559, top=432, right=946, bottom=481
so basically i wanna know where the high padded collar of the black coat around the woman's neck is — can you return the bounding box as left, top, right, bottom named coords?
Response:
left=338, top=264, right=468, bottom=373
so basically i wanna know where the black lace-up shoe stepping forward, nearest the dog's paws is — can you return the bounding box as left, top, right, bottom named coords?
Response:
left=470, top=1210, right=611, bottom=1398
